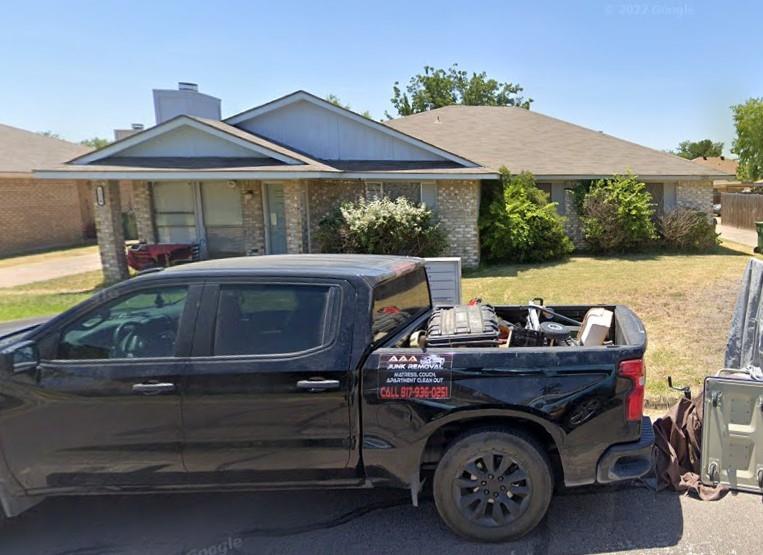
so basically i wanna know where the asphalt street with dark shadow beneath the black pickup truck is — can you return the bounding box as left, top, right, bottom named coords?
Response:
left=0, top=488, right=763, bottom=555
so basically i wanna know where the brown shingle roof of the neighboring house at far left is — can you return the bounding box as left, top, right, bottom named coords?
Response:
left=0, top=124, right=91, bottom=174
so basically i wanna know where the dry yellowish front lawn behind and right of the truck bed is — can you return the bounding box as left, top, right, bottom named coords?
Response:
left=463, top=242, right=752, bottom=407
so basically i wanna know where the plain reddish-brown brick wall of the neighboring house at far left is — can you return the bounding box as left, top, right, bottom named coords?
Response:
left=0, top=178, right=88, bottom=255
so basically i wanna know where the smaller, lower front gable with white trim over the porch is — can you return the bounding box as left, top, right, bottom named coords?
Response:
left=71, top=116, right=309, bottom=165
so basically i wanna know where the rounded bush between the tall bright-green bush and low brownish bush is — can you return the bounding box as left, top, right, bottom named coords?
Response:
left=581, top=174, right=657, bottom=252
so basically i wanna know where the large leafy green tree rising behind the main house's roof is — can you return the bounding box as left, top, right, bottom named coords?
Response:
left=387, top=64, right=533, bottom=117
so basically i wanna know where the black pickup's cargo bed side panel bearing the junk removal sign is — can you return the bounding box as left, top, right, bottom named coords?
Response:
left=361, top=305, right=646, bottom=485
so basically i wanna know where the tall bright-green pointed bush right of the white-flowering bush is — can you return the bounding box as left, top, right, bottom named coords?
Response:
left=480, top=168, right=574, bottom=262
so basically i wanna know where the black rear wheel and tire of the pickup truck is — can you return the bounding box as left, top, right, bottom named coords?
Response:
left=433, top=429, right=554, bottom=542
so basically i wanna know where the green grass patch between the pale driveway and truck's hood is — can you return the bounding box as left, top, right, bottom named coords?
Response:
left=0, top=270, right=103, bottom=322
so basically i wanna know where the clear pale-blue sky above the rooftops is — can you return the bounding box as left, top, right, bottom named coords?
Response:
left=0, top=0, right=763, bottom=156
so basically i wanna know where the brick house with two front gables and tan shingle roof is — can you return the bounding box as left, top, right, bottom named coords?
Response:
left=36, top=84, right=736, bottom=280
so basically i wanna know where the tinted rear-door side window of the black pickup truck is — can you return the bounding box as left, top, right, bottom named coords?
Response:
left=213, top=284, right=331, bottom=356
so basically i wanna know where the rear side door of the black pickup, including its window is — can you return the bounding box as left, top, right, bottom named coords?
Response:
left=182, top=278, right=357, bottom=484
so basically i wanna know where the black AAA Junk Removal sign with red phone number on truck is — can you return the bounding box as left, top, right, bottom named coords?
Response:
left=379, top=353, right=453, bottom=399
